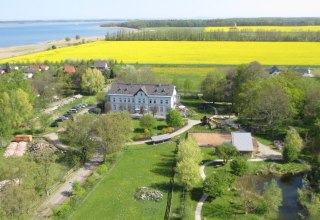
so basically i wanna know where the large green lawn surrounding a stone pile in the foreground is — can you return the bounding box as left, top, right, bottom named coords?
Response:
left=71, top=144, right=175, bottom=220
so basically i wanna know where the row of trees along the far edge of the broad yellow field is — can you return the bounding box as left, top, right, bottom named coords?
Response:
left=105, top=28, right=320, bottom=42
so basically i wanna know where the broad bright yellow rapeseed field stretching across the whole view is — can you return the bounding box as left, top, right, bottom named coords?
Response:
left=0, top=41, right=320, bottom=65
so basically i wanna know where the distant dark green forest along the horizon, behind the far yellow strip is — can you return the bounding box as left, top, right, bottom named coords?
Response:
left=101, top=18, right=320, bottom=29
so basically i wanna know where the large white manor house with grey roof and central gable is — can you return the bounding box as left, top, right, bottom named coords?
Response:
left=107, top=83, right=179, bottom=116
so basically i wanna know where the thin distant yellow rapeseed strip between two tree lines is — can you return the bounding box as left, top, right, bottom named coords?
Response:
left=204, top=26, right=320, bottom=32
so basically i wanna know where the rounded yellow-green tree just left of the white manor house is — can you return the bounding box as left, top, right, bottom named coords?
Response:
left=81, top=69, right=105, bottom=95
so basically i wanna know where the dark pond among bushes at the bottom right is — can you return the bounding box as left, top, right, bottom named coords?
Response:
left=252, top=174, right=305, bottom=220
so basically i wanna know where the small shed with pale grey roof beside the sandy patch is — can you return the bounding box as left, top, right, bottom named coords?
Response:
left=231, top=132, right=253, bottom=154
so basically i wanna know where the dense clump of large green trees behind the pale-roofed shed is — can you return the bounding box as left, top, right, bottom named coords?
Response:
left=201, top=62, right=320, bottom=146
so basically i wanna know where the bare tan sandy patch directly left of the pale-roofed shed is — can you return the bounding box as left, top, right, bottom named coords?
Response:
left=191, top=133, right=231, bottom=147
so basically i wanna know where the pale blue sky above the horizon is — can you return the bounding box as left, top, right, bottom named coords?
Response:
left=0, top=0, right=320, bottom=20
